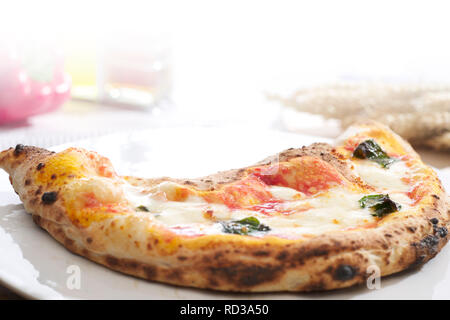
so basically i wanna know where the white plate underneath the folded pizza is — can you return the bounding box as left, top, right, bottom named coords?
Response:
left=0, top=128, right=450, bottom=299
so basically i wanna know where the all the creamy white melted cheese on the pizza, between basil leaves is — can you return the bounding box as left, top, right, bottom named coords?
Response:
left=115, top=136, right=413, bottom=238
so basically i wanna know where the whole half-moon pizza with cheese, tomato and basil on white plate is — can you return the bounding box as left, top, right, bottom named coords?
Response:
left=0, top=121, right=450, bottom=292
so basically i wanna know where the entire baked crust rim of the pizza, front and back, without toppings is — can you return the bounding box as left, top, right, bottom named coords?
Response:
left=0, top=122, right=450, bottom=292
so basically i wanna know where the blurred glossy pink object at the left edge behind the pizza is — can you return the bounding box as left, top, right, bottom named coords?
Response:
left=0, top=48, right=71, bottom=125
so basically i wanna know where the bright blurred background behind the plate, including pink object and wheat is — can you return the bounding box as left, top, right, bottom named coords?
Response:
left=0, top=0, right=450, bottom=162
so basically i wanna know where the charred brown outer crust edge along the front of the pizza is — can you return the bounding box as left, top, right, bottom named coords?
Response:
left=0, top=134, right=450, bottom=292
